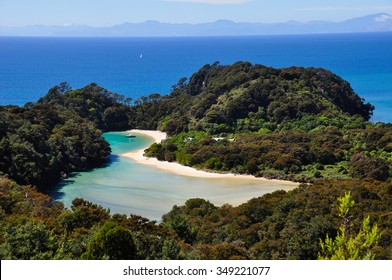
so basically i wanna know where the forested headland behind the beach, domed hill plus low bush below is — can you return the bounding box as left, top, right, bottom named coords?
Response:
left=136, top=62, right=392, bottom=181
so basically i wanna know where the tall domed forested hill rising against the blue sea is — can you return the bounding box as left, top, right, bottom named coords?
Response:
left=131, top=62, right=374, bottom=134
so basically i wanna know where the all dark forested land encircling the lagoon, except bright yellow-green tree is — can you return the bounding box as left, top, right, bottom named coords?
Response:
left=0, top=62, right=392, bottom=259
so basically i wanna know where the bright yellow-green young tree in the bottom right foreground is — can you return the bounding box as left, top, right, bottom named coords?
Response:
left=318, top=192, right=381, bottom=260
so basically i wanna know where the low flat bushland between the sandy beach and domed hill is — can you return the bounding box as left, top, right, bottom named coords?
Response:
left=146, top=127, right=392, bottom=181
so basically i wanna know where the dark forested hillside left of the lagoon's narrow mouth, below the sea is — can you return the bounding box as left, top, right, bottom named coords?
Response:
left=0, top=83, right=130, bottom=188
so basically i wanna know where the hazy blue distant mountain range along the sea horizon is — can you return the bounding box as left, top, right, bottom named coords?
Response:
left=0, top=13, right=392, bottom=37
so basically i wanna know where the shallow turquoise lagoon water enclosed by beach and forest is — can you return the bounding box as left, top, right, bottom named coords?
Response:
left=49, top=132, right=298, bottom=220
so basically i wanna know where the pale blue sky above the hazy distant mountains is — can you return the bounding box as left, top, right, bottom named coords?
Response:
left=0, top=0, right=392, bottom=26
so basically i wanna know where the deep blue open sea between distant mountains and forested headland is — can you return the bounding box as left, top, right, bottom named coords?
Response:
left=0, top=33, right=392, bottom=122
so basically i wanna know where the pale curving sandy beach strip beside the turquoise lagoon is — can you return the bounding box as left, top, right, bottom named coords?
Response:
left=122, top=129, right=299, bottom=186
